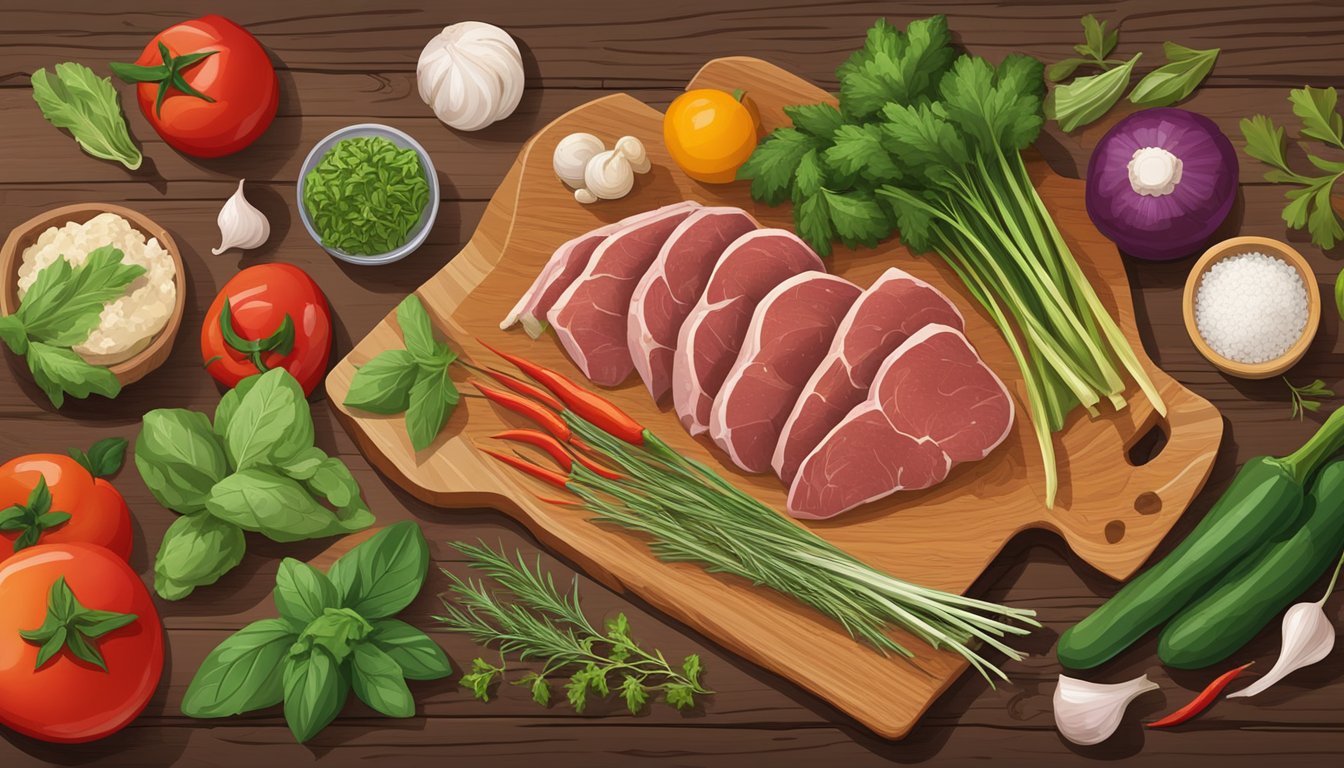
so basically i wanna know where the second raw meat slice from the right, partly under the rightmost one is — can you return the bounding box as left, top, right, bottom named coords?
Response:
left=770, top=268, right=964, bottom=484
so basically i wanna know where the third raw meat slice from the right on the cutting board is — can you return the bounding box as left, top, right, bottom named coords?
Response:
left=710, top=273, right=862, bottom=472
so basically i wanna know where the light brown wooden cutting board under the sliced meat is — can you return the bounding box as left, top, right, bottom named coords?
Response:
left=327, top=58, right=1223, bottom=738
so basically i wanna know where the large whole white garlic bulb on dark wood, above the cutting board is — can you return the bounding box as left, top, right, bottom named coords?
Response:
left=415, top=22, right=524, bottom=130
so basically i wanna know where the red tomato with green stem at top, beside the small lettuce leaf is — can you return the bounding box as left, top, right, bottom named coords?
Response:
left=112, top=15, right=280, bottom=157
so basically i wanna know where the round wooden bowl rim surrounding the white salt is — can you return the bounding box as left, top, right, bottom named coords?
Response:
left=1183, top=237, right=1321, bottom=379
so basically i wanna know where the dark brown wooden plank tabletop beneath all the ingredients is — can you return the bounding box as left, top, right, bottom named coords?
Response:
left=0, top=0, right=1344, bottom=768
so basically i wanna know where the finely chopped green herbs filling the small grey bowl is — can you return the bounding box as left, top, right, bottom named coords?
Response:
left=304, top=136, right=429, bottom=256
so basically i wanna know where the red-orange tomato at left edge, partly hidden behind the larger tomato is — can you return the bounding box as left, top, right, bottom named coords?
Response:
left=0, top=453, right=130, bottom=561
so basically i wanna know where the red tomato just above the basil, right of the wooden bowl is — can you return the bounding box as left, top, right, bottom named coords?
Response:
left=200, top=264, right=332, bottom=394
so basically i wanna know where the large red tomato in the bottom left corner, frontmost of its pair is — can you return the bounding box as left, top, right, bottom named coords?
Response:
left=0, top=543, right=164, bottom=744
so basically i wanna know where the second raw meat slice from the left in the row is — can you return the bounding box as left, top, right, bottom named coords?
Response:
left=546, top=203, right=699, bottom=386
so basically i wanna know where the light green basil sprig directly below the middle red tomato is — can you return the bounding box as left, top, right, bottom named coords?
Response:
left=136, top=369, right=374, bottom=600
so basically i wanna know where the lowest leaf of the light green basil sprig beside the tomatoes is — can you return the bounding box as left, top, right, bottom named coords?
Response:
left=155, top=515, right=247, bottom=600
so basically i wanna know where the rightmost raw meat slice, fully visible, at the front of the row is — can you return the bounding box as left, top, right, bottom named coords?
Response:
left=789, top=325, right=1013, bottom=519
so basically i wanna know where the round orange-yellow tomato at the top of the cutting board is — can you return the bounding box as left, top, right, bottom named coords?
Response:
left=663, top=87, right=759, bottom=184
